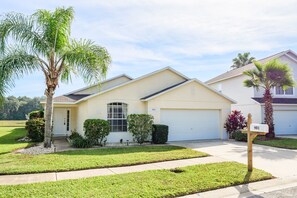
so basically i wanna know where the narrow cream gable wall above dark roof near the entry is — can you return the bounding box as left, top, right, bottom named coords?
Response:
left=75, top=76, right=130, bottom=94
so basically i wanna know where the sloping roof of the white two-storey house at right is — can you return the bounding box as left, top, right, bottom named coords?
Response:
left=205, top=50, right=297, bottom=85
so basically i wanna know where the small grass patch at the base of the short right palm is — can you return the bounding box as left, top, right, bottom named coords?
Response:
left=254, top=138, right=297, bottom=149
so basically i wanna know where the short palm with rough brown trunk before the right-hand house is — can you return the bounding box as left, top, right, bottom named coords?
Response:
left=243, top=59, right=295, bottom=138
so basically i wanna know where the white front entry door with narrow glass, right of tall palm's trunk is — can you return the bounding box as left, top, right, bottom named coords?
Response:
left=53, top=108, right=70, bottom=136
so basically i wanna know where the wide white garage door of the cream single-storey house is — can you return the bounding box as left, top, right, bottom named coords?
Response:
left=161, top=109, right=220, bottom=141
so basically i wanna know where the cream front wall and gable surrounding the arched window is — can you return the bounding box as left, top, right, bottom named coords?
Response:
left=77, top=70, right=185, bottom=142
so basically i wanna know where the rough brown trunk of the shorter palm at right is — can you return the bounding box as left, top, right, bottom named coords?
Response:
left=264, top=89, right=275, bottom=138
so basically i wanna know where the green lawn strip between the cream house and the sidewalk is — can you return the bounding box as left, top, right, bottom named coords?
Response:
left=0, top=127, right=207, bottom=174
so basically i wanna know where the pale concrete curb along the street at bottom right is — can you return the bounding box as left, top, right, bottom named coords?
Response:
left=182, top=176, right=297, bottom=198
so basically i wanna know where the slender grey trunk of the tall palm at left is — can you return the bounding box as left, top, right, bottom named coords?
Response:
left=44, top=88, right=54, bottom=148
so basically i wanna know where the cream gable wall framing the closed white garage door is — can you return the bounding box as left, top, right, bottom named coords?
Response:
left=148, top=82, right=231, bottom=139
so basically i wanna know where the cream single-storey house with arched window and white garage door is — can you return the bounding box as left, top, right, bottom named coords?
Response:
left=42, top=67, right=233, bottom=142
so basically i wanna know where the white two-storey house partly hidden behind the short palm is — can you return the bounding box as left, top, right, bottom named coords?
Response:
left=206, top=50, right=297, bottom=135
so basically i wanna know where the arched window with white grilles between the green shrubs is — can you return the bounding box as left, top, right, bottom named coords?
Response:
left=107, top=102, right=127, bottom=132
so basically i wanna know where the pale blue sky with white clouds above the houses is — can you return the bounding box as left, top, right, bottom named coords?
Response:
left=0, top=0, right=297, bottom=96
